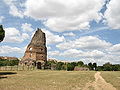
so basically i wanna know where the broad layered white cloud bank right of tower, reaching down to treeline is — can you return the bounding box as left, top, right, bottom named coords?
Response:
left=49, top=36, right=120, bottom=65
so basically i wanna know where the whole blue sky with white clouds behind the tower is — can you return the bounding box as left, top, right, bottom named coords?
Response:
left=0, top=0, right=120, bottom=65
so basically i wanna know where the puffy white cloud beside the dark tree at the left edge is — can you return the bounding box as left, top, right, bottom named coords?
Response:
left=4, top=27, right=29, bottom=43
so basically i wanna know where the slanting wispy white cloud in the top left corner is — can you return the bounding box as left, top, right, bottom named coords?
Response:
left=4, top=0, right=24, bottom=18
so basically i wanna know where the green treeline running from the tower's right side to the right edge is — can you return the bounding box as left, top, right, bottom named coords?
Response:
left=46, top=60, right=120, bottom=71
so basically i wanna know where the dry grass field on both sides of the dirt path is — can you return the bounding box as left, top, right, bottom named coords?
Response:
left=0, top=70, right=120, bottom=90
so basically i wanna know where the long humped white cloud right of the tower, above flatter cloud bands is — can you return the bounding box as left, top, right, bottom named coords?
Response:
left=56, top=36, right=112, bottom=50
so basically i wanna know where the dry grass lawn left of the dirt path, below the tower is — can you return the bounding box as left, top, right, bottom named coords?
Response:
left=0, top=70, right=95, bottom=90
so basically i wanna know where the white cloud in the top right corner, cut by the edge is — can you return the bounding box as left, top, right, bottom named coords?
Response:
left=104, top=0, right=120, bottom=29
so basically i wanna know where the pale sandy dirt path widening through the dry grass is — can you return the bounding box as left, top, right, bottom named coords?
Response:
left=82, top=72, right=116, bottom=90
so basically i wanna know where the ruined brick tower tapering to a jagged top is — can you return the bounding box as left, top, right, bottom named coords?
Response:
left=22, top=28, right=47, bottom=69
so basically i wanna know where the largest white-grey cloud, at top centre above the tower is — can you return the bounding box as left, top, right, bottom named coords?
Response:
left=25, top=0, right=105, bottom=32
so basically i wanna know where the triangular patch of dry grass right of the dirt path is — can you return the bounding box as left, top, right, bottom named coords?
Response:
left=101, top=71, right=120, bottom=90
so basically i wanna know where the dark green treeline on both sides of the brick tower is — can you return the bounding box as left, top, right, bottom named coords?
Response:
left=0, top=59, right=120, bottom=71
